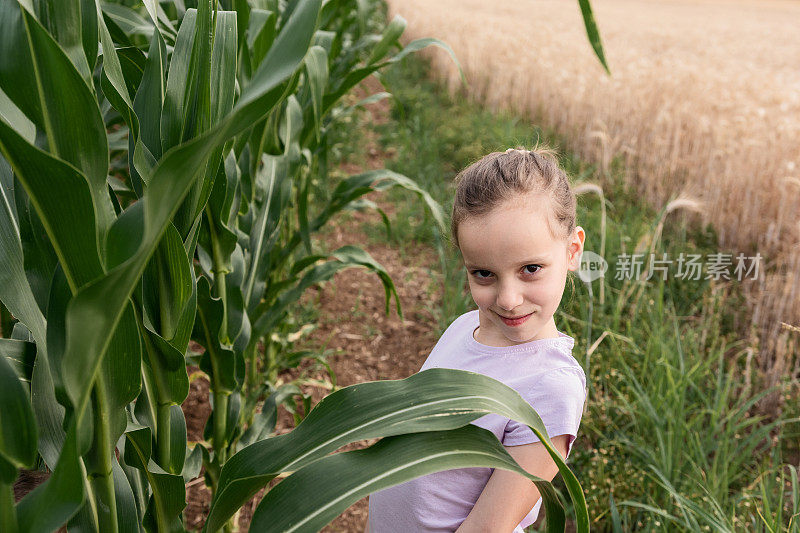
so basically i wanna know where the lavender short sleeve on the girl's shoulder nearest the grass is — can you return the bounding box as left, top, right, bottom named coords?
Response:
left=502, top=367, right=586, bottom=455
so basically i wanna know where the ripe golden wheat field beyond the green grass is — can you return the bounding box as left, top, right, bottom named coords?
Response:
left=389, top=0, right=800, bottom=382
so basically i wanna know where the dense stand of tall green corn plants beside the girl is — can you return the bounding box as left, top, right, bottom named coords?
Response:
left=0, top=0, right=604, bottom=532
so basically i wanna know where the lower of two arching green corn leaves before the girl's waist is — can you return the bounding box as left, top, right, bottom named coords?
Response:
left=250, top=424, right=564, bottom=533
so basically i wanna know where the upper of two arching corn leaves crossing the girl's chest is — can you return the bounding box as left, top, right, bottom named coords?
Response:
left=205, top=368, right=589, bottom=531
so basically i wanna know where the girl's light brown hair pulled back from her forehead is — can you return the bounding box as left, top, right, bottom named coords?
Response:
left=450, top=147, right=575, bottom=247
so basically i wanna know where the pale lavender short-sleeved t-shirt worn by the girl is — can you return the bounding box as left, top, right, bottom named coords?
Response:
left=369, top=309, right=586, bottom=533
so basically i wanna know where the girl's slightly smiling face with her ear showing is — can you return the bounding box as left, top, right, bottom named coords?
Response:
left=458, top=195, right=585, bottom=346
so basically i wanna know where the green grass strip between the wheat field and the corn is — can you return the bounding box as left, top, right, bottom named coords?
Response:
left=340, top=51, right=798, bottom=532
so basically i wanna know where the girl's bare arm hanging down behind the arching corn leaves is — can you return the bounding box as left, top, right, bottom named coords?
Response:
left=456, top=435, right=569, bottom=533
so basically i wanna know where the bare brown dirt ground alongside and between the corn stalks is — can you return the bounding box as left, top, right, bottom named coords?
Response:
left=183, top=80, right=441, bottom=533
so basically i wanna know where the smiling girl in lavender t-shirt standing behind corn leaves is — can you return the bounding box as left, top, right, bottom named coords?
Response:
left=366, top=149, right=586, bottom=533
